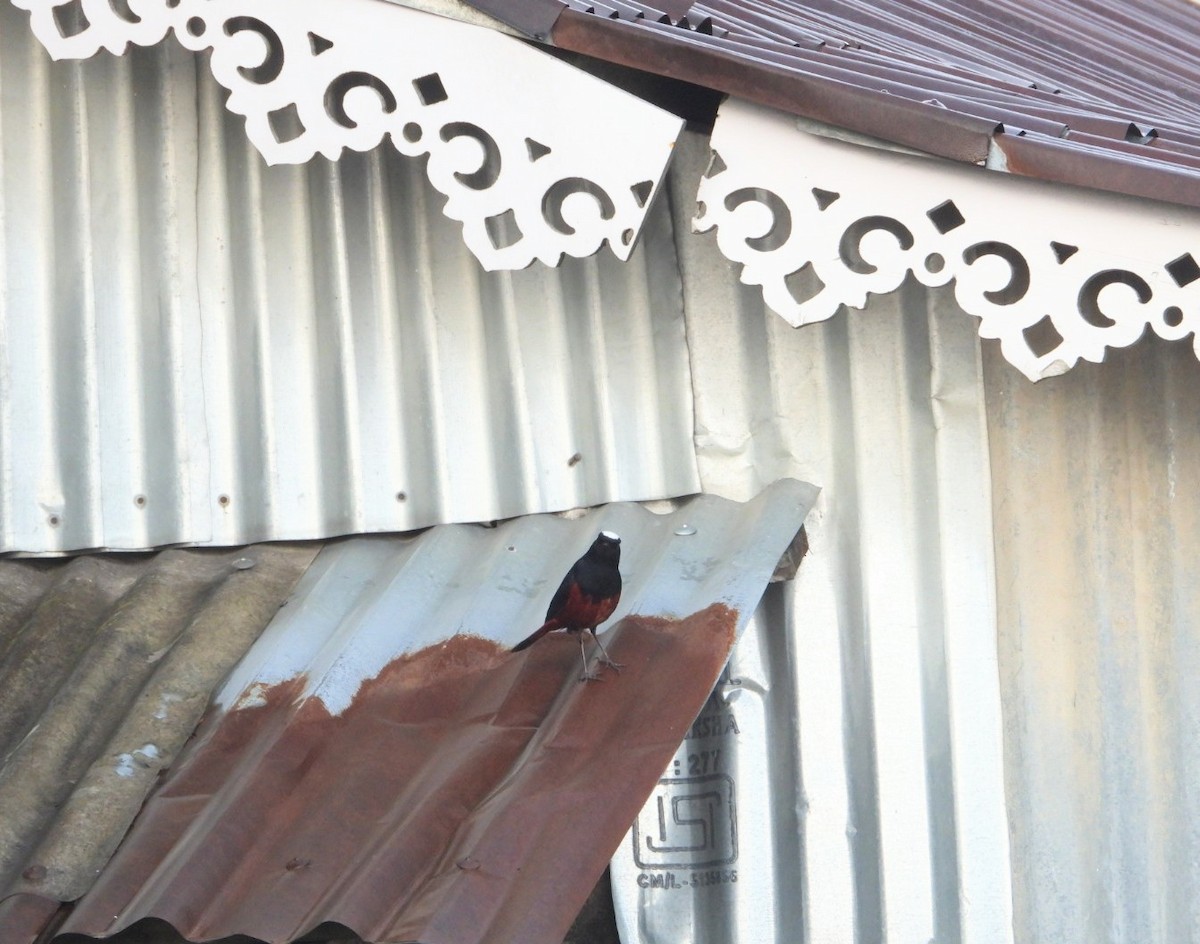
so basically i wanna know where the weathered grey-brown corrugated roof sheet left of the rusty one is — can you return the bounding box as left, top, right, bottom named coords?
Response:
left=0, top=545, right=317, bottom=906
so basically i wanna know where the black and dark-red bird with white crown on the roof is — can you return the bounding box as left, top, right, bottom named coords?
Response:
left=512, top=531, right=620, bottom=681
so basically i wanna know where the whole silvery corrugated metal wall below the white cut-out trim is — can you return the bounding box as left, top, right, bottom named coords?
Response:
left=0, top=1, right=1200, bottom=944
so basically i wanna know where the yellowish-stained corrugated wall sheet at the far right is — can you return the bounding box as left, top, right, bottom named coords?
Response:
left=984, top=338, right=1200, bottom=944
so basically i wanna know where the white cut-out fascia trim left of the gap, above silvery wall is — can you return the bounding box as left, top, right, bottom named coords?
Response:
left=13, top=0, right=682, bottom=269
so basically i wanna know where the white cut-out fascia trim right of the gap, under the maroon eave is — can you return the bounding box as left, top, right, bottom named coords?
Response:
left=695, top=100, right=1200, bottom=380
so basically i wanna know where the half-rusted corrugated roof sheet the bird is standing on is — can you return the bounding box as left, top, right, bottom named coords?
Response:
left=32, top=481, right=815, bottom=944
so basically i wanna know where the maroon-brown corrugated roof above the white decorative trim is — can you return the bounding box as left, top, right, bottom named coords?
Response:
left=468, top=0, right=1200, bottom=206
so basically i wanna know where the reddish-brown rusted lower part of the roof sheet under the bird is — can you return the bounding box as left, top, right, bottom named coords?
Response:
left=65, top=605, right=737, bottom=944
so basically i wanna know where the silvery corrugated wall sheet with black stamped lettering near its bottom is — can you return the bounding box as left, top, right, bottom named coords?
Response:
left=613, top=136, right=1012, bottom=944
